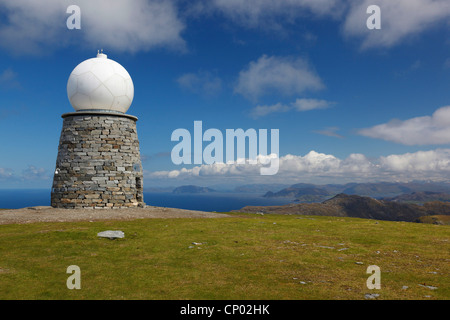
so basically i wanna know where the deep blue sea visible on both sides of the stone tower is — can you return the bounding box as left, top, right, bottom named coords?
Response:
left=0, top=189, right=293, bottom=212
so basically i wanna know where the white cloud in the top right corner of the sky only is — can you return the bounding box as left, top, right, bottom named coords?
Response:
left=343, top=0, right=450, bottom=49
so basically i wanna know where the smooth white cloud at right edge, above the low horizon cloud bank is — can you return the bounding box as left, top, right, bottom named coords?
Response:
left=359, top=106, right=450, bottom=145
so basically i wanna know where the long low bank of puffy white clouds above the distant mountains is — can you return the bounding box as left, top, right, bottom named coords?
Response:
left=145, top=149, right=450, bottom=183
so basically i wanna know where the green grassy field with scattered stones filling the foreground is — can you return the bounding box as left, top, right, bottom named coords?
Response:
left=0, top=214, right=450, bottom=300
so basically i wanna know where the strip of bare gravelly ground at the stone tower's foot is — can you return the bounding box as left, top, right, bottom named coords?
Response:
left=0, top=206, right=229, bottom=225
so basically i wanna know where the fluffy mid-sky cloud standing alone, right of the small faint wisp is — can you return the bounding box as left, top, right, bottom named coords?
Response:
left=234, top=55, right=324, bottom=100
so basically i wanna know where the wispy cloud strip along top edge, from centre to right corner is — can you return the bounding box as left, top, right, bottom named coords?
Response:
left=190, top=0, right=450, bottom=48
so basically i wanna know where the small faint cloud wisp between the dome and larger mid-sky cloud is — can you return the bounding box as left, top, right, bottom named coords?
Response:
left=177, top=71, right=222, bottom=96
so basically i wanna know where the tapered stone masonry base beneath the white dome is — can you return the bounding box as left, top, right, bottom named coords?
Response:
left=51, top=113, right=145, bottom=209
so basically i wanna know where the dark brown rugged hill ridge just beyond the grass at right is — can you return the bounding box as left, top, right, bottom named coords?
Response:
left=235, top=194, right=450, bottom=221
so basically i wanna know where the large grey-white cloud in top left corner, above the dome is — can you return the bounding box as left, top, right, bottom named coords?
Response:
left=0, top=0, right=185, bottom=55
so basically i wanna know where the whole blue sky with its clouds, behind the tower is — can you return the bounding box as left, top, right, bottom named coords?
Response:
left=0, top=0, right=450, bottom=188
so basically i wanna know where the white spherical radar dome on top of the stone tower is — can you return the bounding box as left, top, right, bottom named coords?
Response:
left=67, top=53, right=134, bottom=113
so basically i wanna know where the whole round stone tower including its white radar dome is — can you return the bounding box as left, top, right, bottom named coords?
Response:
left=51, top=53, right=145, bottom=209
